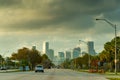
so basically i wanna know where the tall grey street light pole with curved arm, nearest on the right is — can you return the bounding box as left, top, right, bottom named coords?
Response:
left=96, top=19, right=117, bottom=74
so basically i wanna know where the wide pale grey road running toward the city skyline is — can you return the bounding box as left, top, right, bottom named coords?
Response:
left=0, top=69, right=107, bottom=80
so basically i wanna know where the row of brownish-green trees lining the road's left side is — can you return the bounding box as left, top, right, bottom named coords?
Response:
left=0, top=47, right=54, bottom=70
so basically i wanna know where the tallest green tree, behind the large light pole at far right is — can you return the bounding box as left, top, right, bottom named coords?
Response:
left=99, top=37, right=120, bottom=69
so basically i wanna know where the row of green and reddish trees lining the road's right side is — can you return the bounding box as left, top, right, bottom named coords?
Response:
left=60, top=37, right=120, bottom=71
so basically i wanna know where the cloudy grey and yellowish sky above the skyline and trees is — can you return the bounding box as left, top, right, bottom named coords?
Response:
left=0, top=0, right=120, bottom=56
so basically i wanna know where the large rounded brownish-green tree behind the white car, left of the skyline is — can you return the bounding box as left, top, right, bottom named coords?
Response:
left=11, top=47, right=42, bottom=69
